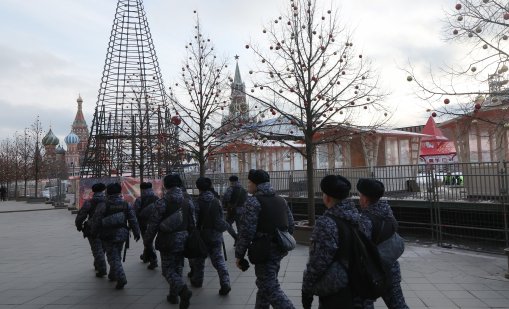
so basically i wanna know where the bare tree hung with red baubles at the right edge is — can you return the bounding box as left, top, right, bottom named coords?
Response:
left=406, top=0, right=509, bottom=162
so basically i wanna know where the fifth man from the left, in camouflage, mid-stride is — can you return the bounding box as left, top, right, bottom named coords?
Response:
left=191, top=177, right=231, bottom=296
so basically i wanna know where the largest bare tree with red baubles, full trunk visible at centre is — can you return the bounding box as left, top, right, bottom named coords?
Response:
left=246, top=0, right=384, bottom=225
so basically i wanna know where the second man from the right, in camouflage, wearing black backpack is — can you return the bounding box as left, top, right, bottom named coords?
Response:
left=302, top=175, right=366, bottom=309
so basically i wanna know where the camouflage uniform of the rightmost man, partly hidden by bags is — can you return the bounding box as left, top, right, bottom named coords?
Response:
left=361, top=200, right=408, bottom=309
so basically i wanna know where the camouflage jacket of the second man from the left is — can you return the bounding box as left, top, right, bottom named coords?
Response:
left=87, top=194, right=140, bottom=242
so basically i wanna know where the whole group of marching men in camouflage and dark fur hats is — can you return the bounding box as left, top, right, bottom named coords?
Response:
left=75, top=169, right=408, bottom=309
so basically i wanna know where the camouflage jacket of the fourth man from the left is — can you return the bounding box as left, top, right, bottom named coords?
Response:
left=143, top=187, right=196, bottom=252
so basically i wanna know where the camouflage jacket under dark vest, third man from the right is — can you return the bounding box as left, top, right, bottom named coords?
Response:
left=235, top=182, right=294, bottom=259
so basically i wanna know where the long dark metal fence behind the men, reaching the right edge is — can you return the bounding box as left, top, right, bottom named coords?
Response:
left=185, top=162, right=509, bottom=252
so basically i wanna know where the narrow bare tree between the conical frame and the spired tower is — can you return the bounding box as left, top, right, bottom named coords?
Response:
left=170, top=11, right=252, bottom=176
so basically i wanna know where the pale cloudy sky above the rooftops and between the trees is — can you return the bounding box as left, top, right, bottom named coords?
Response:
left=0, top=0, right=459, bottom=146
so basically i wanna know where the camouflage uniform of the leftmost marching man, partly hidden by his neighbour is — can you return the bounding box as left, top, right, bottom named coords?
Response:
left=75, top=192, right=106, bottom=275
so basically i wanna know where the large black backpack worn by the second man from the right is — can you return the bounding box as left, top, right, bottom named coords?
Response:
left=327, top=215, right=389, bottom=300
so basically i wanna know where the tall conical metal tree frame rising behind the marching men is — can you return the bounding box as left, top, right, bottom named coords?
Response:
left=81, top=0, right=178, bottom=180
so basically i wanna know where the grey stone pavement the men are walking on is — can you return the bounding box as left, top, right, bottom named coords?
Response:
left=0, top=202, right=509, bottom=309
